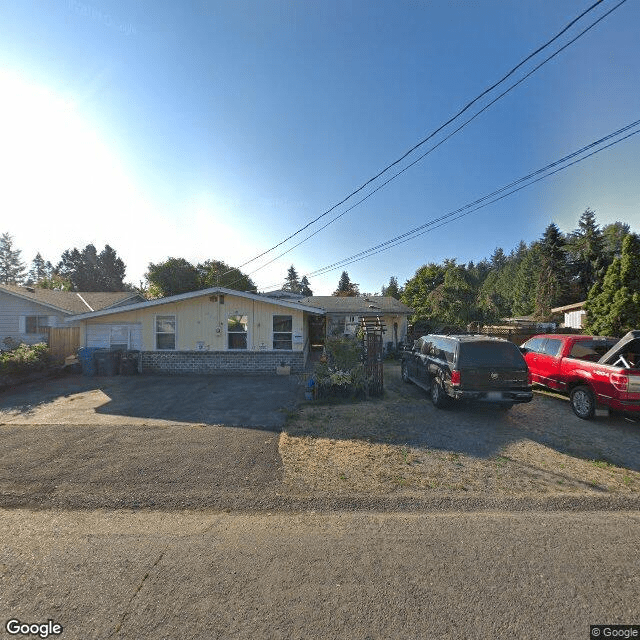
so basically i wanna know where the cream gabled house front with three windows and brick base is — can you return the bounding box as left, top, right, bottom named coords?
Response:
left=71, top=287, right=324, bottom=373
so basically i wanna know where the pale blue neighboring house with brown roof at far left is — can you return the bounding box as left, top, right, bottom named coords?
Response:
left=0, top=284, right=144, bottom=346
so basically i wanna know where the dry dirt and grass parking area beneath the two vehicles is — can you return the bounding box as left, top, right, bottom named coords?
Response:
left=279, top=364, right=640, bottom=496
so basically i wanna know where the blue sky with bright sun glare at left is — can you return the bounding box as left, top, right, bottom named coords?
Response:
left=0, top=0, right=640, bottom=295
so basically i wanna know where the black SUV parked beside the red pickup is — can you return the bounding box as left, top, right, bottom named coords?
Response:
left=402, top=335, right=533, bottom=408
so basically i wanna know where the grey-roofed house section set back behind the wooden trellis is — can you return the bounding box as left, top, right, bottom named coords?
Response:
left=300, top=296, right=413, bottom=347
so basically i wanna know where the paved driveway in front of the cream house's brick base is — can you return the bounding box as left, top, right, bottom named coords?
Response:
left=0, top=376, right=302, bottom=509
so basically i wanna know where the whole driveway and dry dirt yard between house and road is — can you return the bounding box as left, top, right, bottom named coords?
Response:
left=0, top=364, right=640, bottom=510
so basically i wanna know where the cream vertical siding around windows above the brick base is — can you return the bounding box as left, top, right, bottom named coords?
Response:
left=80, top=294, right=307, bottom=351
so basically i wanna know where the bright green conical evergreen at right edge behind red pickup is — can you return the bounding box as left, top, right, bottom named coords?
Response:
left=585, top=234, right=640, bottom=336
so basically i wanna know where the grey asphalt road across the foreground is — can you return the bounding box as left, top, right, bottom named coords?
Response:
left=0, top=510, right=640, bottom=640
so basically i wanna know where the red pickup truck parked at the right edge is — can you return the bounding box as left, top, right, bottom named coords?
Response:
left=520, top=331, right=640, bottom=420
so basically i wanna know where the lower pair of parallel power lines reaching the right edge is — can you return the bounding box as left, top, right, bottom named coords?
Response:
left=305, top=120, right=640, bottom=277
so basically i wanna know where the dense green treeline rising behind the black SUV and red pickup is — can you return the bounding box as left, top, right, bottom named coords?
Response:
left=398, top=209, right=640, bottom=333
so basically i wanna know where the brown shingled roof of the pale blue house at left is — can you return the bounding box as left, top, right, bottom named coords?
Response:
left=0, top=284, right=143, bottom=314
